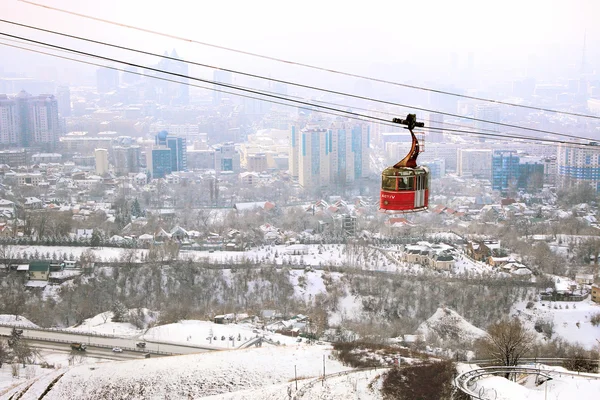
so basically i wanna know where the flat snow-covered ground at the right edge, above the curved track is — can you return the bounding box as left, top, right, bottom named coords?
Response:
left=511, top=299, right=600, bottom=349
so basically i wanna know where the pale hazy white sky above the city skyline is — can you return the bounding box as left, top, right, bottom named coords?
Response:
left=0, top=0, right=600, bottom=88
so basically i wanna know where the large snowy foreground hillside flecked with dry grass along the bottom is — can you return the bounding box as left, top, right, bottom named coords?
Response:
left=44, top=346, right=348, bottom=400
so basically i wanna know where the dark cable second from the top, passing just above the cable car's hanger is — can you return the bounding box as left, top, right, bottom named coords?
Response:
left=0, top=19, right=600, bottom=144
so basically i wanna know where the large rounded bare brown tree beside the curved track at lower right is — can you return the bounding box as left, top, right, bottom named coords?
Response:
left=478, top=318, right=535, bottom=366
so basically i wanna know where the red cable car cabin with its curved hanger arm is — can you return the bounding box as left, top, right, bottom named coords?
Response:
left=379, top=114, right=429, bottom=214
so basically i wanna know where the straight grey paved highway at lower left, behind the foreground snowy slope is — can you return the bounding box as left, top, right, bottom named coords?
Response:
left=0, top=326, right=219, bottom=355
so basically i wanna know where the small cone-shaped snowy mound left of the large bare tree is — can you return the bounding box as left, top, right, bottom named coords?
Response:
left=417, top=308, right=486, bottom=342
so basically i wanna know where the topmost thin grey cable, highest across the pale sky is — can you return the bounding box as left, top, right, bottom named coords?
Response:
left=18, top=0, right=600, bottom=119
